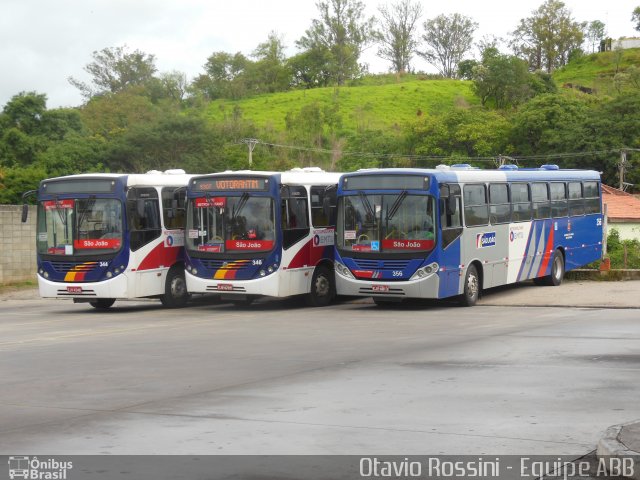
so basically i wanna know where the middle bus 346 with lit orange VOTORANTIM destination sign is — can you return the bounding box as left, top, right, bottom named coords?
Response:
left=185, top=168, right=340, bottom=306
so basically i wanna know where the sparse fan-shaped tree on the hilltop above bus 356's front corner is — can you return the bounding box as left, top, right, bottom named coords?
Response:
left=418, top=13, right=478, bottom=78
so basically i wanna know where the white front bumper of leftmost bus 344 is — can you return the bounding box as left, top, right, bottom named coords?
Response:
left=38, top=274, right=130, bottom=299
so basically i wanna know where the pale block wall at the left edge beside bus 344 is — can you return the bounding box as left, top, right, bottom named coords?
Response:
left=0, top=205, right=36, bottom=285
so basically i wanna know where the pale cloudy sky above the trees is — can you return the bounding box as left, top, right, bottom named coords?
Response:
left=0, top=0, right=640, bottom=108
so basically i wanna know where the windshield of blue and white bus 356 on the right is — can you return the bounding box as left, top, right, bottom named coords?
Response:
left=336, top=191, right=436, bottom=253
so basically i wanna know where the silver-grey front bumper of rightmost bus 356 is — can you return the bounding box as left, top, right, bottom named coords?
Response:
left=336, top=273, right=440, bottom=300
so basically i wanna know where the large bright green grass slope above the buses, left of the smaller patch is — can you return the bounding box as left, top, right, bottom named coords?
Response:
left=207, top=76, right=480, bottom=130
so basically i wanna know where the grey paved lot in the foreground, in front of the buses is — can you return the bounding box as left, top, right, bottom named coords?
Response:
left=0, top=299, right=640, bottom=455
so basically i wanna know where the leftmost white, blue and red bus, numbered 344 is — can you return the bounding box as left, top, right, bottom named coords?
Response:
left=23, top=170, right=191, bottom=309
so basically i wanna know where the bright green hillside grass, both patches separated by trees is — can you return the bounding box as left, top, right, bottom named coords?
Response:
left=207, top=49, right=640, bottom=131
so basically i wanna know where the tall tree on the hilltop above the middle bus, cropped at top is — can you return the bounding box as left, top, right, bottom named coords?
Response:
left=296, top=0, right=377, bottom=85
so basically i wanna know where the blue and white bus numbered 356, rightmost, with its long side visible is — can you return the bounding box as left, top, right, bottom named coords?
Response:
left=335, top=165, right=603, bottom=306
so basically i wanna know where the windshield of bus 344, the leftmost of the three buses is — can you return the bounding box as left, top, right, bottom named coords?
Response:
left=37, top=197, right=122, bottom=256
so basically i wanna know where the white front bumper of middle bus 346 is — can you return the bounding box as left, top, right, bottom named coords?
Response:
left=184, top=272, right=282, bottom=297
